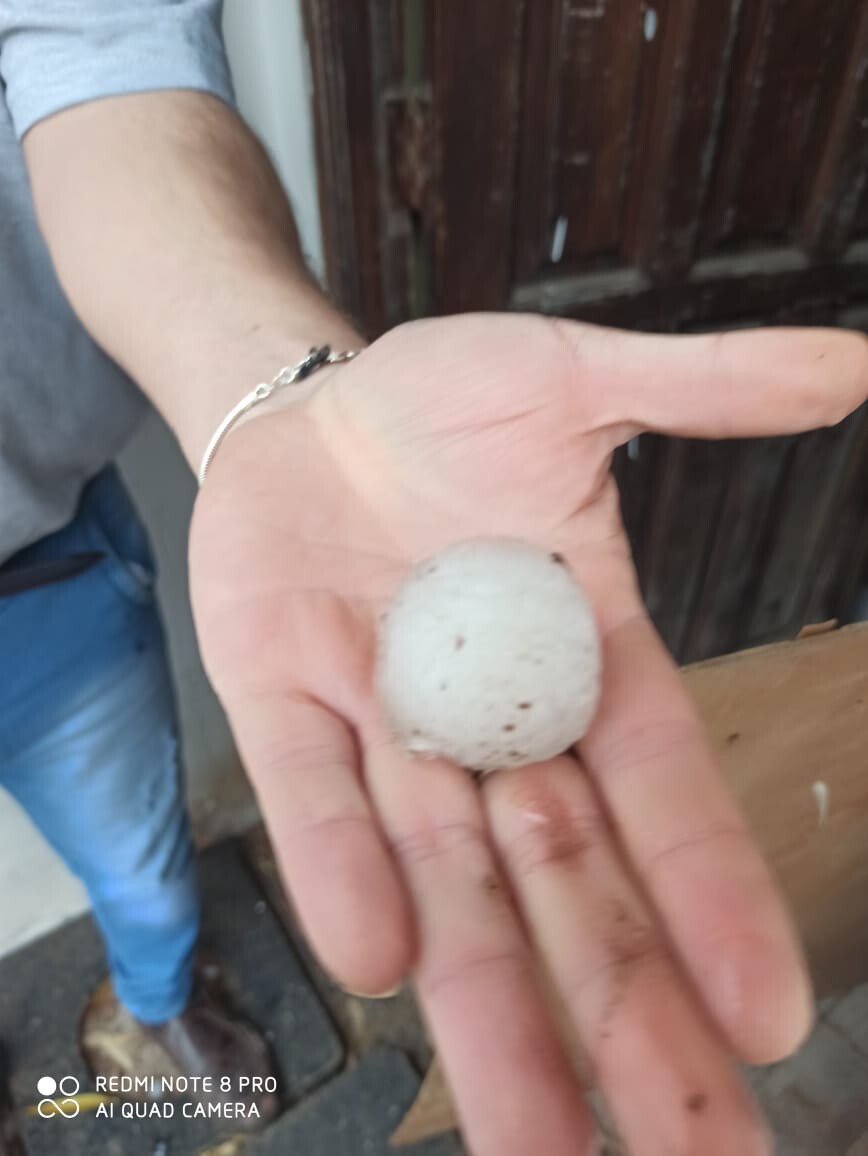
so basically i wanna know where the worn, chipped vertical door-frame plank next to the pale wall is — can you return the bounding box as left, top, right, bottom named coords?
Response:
left=304, top=0, right=428, bottom=336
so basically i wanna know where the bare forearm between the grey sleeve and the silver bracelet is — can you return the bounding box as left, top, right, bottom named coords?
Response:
left=24, top=91, right=359, bottom=468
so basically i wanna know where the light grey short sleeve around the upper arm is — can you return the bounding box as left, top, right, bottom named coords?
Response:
left=0, top=0, right=232, bottom=136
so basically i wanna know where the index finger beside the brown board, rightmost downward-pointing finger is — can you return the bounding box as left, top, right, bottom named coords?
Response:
left=580, top=615, right=813, bottom=1062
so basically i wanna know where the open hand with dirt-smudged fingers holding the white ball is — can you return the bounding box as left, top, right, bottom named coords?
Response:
left=191, top=316, right=868, bottom=1156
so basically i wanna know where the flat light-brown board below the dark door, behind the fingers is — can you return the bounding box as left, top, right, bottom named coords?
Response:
left=395, top=624, right=868, bottom=1144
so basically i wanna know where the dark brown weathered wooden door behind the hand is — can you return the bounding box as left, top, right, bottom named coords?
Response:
left=305, top=0, right=868, bottom=659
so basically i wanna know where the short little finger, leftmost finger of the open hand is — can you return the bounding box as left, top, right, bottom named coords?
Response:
left=230, top=695, right=414, bottom=994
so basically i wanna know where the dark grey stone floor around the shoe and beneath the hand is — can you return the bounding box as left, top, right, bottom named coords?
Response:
left=0, top=828, right=868, bottom=1156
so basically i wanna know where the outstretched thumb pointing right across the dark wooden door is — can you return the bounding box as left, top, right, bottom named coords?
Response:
left=556, top=320, right=868, bottom=438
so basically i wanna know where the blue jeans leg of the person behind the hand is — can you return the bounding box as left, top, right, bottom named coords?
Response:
left=0, top=468, right=199, bottom=1023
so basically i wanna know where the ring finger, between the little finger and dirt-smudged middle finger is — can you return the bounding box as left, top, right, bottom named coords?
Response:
left=366, top=739, right=593, bottom=1156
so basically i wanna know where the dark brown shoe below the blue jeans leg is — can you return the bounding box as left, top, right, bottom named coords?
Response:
left=144, top=994, right=280, bottom=1131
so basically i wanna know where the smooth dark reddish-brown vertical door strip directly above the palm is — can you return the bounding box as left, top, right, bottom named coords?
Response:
left=431, top=0, right=525, bottom=312
